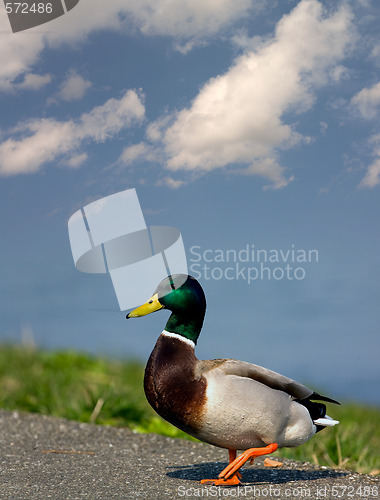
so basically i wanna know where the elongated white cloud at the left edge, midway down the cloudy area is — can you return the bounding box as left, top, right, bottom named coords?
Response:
left=0, top=90, right=145, bottom=175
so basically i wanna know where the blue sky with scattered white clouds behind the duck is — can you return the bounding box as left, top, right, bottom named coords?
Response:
left=0, top=0, right=380, bottom=404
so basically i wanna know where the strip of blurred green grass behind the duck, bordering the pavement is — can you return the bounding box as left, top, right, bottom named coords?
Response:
left=0, top=345, right=380, bottom=474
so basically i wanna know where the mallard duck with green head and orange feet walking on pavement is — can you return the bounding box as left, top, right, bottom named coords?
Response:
left=127, top=274, right=339, bottom=485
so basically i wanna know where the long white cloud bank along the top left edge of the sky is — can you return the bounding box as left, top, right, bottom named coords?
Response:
left=0, top=0, right=263, bottom=91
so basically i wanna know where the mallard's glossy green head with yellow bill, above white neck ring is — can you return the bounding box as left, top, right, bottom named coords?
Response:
left=127, top=274, right=206, bottom=343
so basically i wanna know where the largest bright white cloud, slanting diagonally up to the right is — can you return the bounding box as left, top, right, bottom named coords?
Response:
left=142, top=0, right=355, bottom=188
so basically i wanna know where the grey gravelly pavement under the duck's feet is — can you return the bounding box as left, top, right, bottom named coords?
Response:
left=0, top=410, right=380, bottom=500
